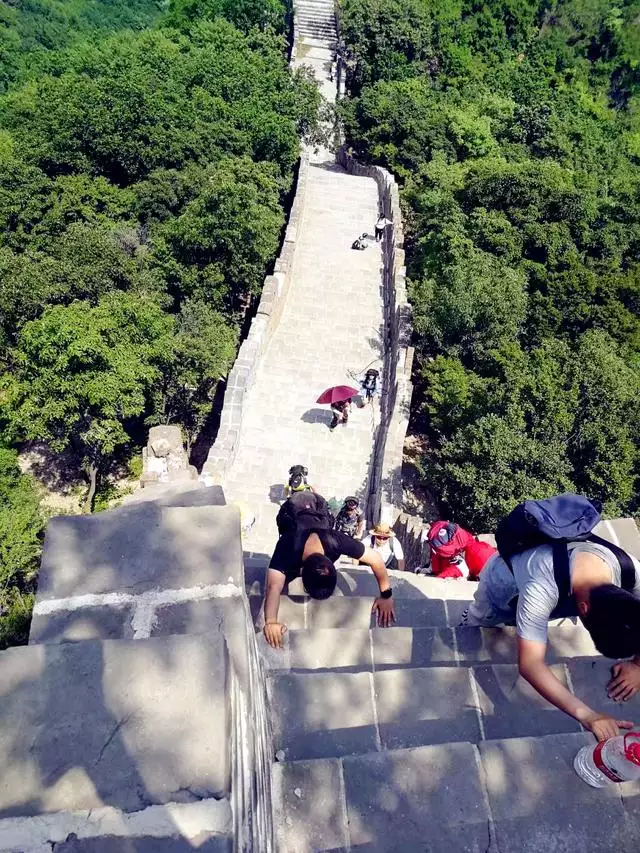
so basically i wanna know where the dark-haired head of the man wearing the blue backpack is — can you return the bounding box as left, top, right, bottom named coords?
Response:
left=578, top=583, right=640, bottom=658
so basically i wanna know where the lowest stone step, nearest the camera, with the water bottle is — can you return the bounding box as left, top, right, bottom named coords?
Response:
left=272, top=733, right=640, bottom=853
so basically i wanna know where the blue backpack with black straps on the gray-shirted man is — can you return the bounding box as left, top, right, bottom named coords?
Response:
left=496, top=492, right=636, bottom=602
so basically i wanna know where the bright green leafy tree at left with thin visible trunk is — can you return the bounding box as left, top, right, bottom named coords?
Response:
left=9, top=293, right=172, bottom=510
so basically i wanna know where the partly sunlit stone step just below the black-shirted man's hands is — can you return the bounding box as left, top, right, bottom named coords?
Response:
left=258, top=622, right=600, bottom=672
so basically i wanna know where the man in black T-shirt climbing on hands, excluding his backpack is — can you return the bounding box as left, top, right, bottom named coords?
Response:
left=264, top=527, right=395, bottom=649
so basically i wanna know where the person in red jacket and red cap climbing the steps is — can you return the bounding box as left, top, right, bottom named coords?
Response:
left=427, top=521, right=497, bottom=581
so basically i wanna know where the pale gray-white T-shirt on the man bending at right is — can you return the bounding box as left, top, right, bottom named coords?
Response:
left=512, top=542, right=640, bottom=643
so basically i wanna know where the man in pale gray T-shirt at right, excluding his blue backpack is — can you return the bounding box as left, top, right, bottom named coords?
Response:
left=462, top=542, right=640, bottom=740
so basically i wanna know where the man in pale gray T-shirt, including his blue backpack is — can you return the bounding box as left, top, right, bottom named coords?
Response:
left=461, top=494, right=640, bottom=741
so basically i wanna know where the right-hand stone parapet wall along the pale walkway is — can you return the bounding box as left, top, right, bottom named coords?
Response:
left=336, top=146, right=413, bottom=523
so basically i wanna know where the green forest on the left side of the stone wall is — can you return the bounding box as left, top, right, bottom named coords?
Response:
left=0, top=0, right=319, bottom=647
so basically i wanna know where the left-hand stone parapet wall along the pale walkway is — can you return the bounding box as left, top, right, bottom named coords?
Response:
left=201, top=153, right=309, bottom=485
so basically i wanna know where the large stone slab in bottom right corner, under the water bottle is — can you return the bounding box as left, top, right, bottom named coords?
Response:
left=480, top=733, right=640, bottom=853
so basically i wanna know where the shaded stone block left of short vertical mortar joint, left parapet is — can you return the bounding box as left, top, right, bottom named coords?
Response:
left=29, top=606, right=133, bottom=645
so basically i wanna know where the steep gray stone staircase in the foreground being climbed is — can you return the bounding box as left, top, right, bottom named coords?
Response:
left=252, top=519, right=640, bottom=853
